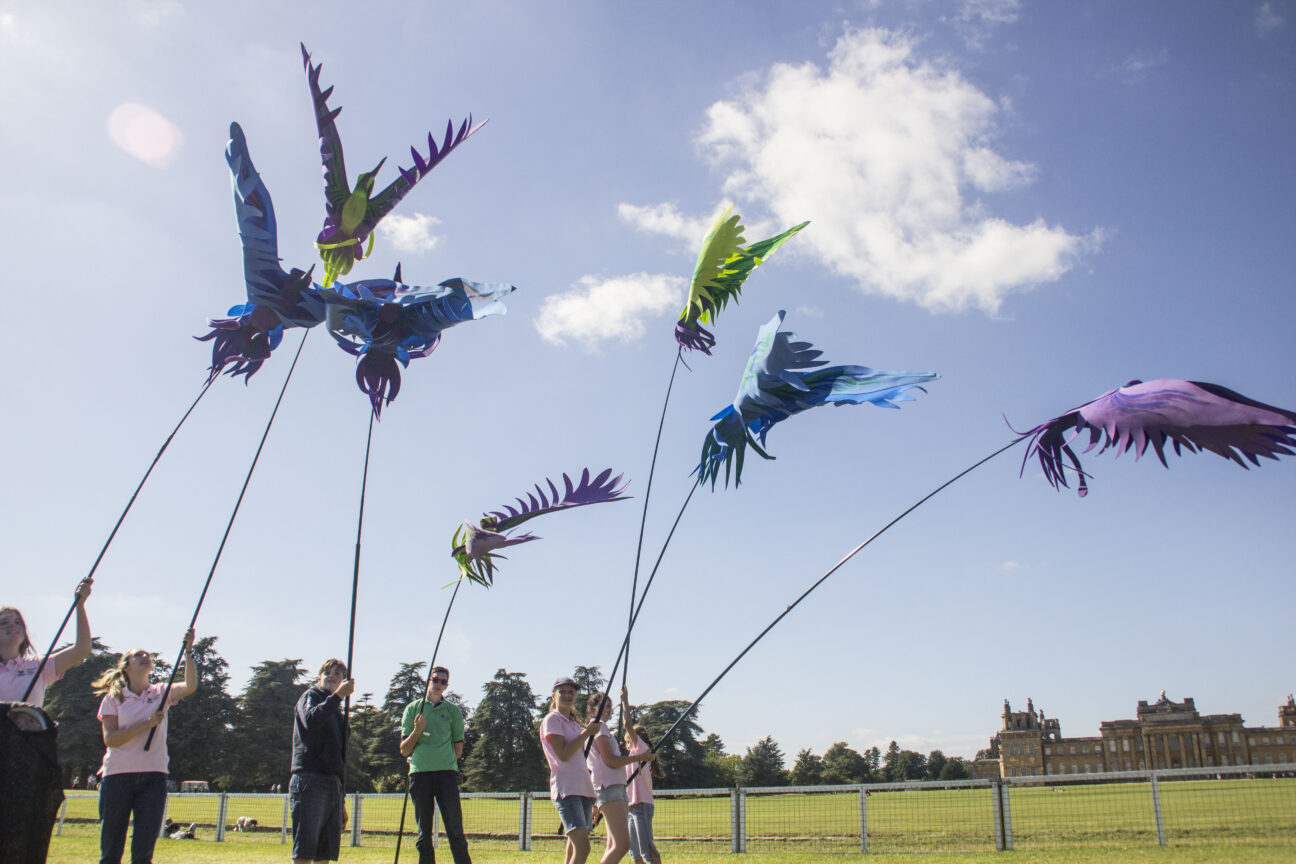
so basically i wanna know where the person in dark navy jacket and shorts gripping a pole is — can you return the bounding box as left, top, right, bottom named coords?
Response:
left=288, top=658, right=355, bottom=864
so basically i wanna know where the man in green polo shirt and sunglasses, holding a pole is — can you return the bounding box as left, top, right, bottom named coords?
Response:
left=400, top=666, right=472, bottom=864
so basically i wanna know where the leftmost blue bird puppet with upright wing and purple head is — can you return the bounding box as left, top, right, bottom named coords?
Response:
left=196, top=123, right=324, bottom=382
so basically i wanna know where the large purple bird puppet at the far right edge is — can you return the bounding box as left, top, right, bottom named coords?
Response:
left=1021, top=378, right=1296, bottom=497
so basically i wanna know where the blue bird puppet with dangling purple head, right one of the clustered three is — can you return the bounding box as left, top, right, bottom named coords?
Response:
left=320, top=270, right=516, bottom=418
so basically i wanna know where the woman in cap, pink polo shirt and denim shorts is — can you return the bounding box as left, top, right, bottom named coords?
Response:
left=540, top=677, right=599, bottom=864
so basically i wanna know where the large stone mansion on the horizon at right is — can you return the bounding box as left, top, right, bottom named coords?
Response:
left=968, top=690, right=1296, bottom=777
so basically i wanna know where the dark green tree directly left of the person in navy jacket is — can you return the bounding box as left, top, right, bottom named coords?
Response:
left=216, top=659, right=311, bottom=791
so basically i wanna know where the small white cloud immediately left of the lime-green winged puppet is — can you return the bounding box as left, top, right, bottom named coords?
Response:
left=535, top=273, right=686, bottom=351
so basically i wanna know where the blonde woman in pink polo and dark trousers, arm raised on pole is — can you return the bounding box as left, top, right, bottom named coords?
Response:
left=95, top=628, right=198, bottom=864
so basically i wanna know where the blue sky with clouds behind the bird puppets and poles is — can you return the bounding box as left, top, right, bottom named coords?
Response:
left=0, top=0, right=1296, bottom=760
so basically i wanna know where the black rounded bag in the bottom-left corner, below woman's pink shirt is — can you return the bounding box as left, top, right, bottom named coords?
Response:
left=0, top=702, right=64, bottom=864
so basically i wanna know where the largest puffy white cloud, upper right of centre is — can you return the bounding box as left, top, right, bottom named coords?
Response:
left=694, top=26, right=1100, bottom=312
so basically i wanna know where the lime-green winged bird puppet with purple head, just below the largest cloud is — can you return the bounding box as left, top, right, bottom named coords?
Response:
left=675, top=205, right=810, bottom=354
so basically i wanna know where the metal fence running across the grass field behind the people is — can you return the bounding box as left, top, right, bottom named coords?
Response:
left=56, top=766, right=1296, bottom=854
